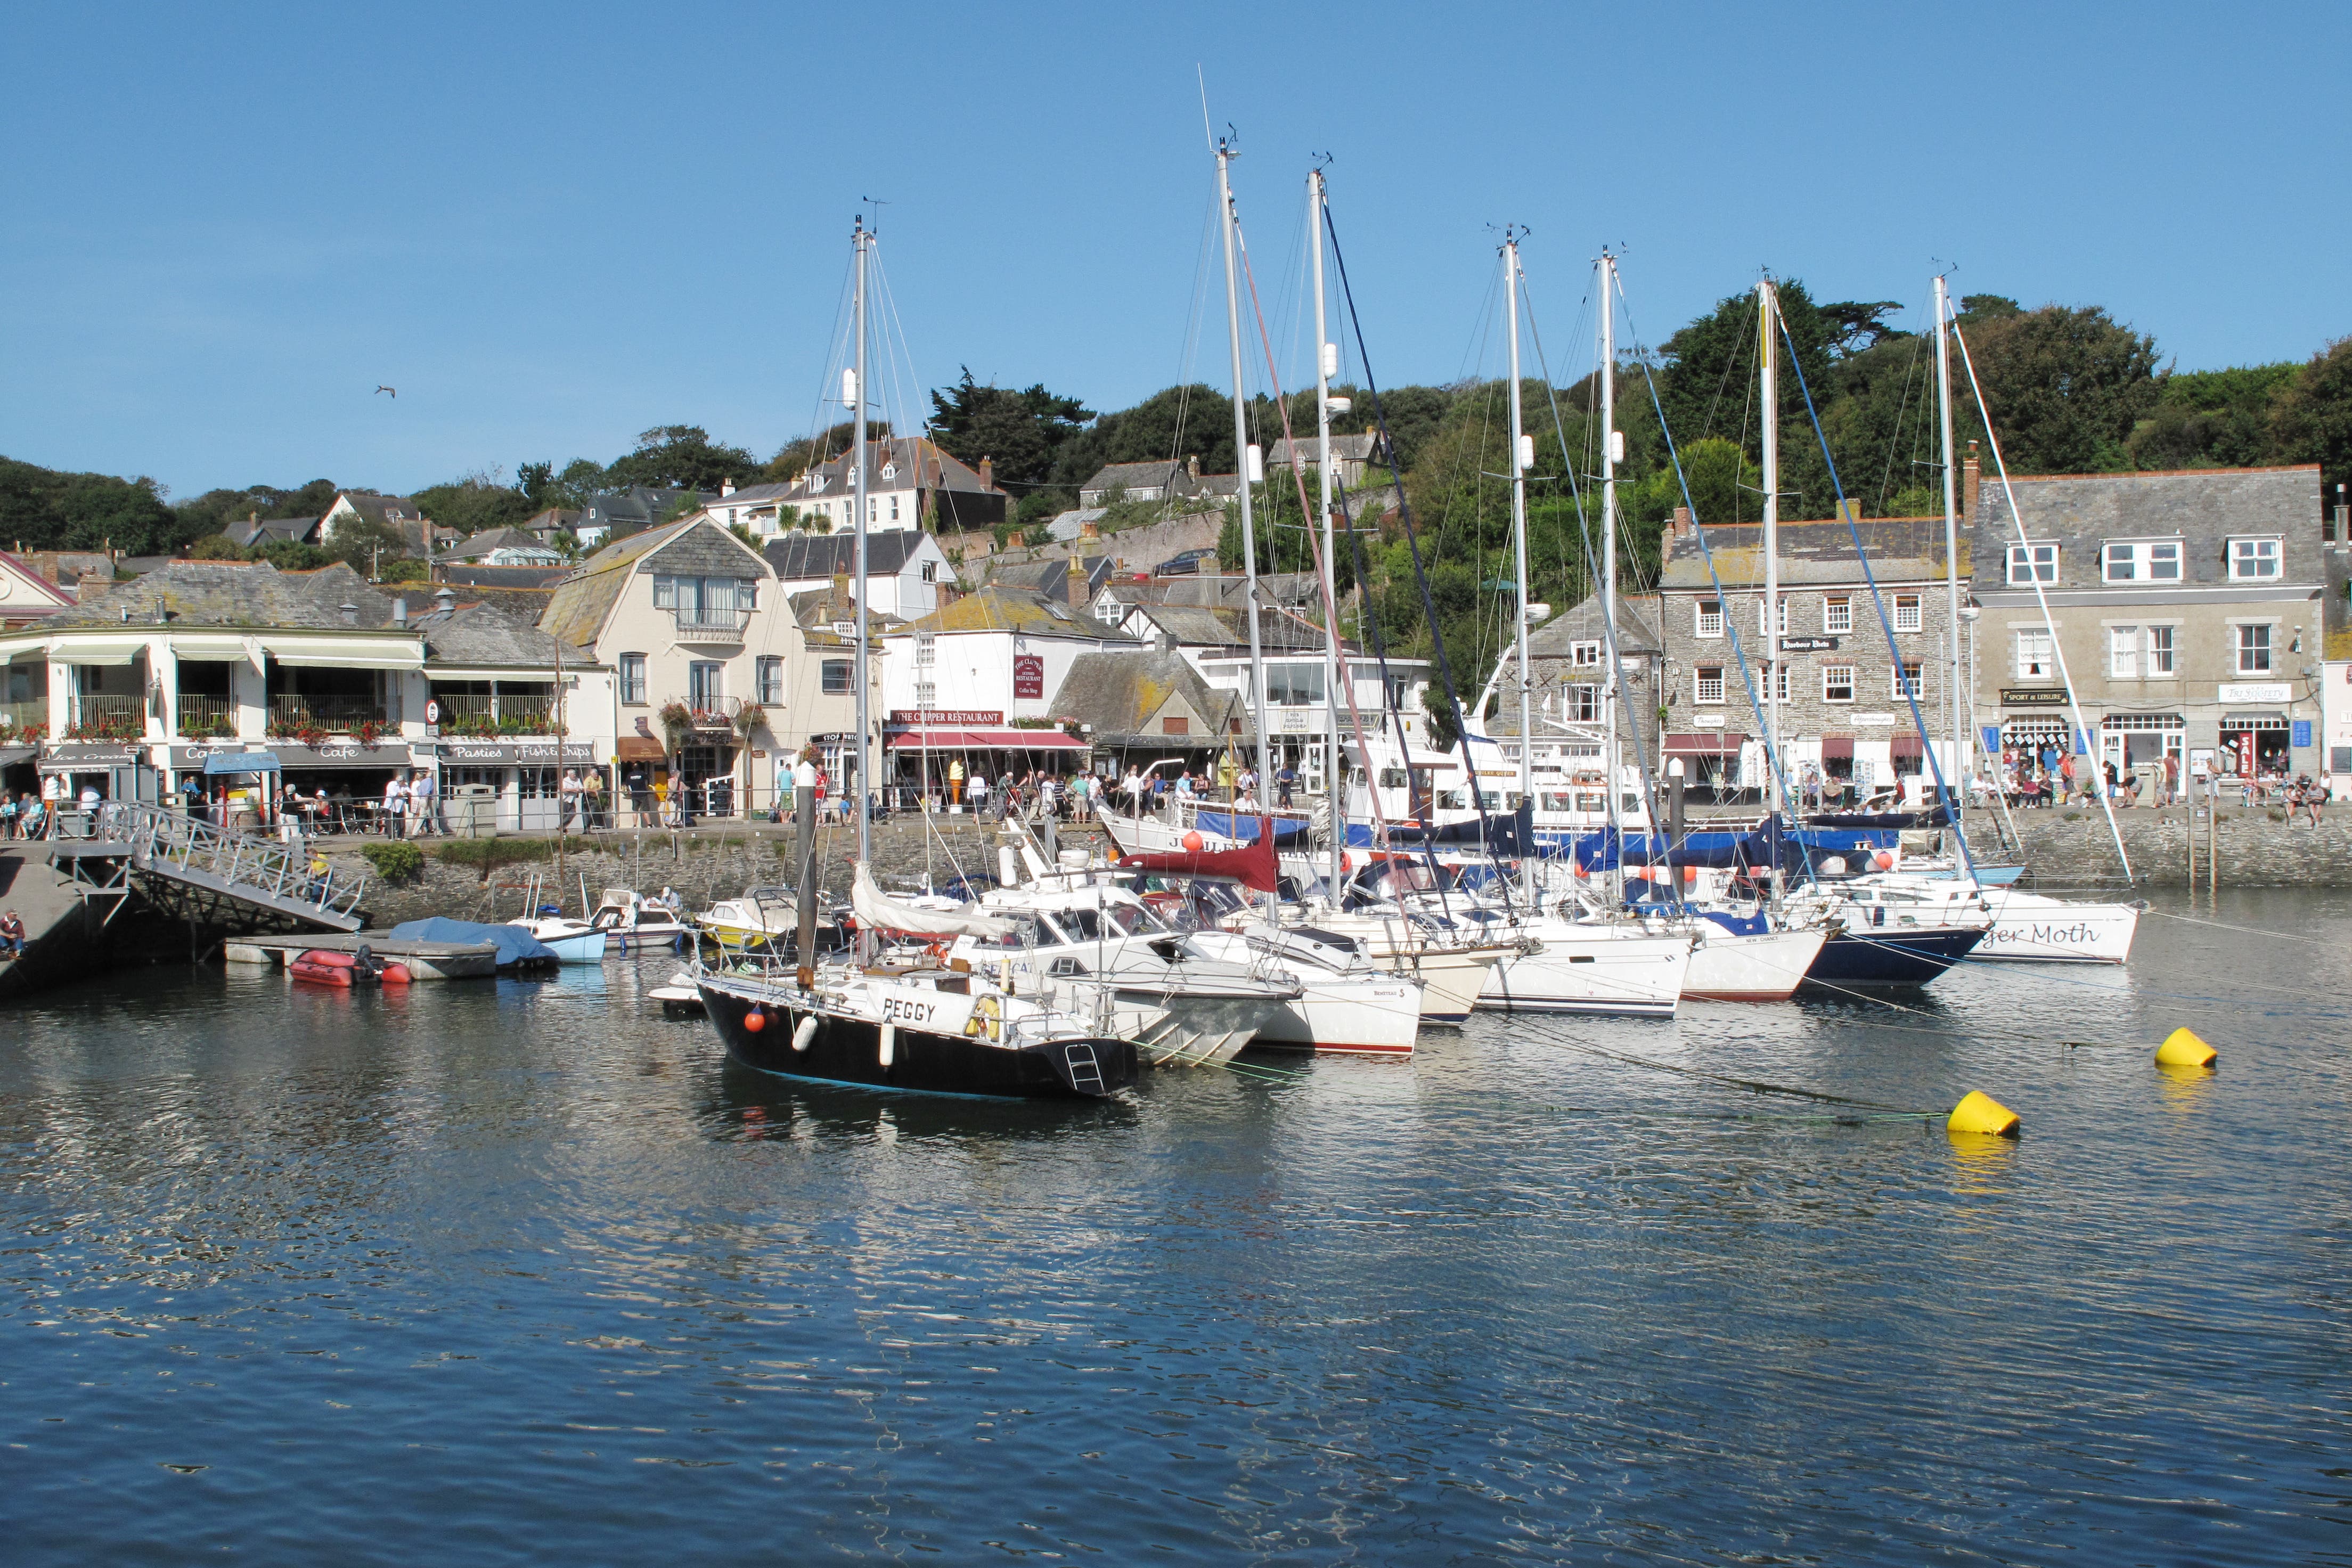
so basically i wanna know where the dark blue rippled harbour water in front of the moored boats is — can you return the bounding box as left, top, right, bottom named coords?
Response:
left=0, top=896, right=2352, bottom=1563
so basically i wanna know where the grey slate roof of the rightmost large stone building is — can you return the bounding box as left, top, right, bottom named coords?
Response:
left=1962, top=463, right=2322, bottom=592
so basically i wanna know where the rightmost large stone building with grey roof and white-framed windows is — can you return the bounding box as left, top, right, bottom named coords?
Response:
left=1971, top=466, right=2326, bottom=785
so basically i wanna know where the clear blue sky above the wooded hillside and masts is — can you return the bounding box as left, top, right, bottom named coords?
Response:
left=0, top=2, right=2352, bottom=496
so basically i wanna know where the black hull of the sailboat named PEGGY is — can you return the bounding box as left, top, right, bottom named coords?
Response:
left=696, top=981, right=1138, bottom=1100
